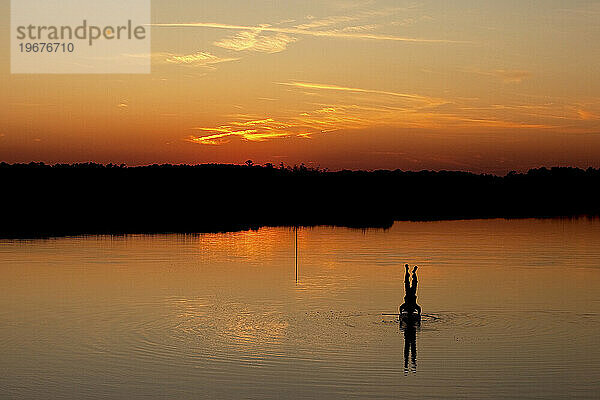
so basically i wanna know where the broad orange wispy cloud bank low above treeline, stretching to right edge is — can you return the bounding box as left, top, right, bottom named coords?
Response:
left=186, top=75, right=584, bottom=145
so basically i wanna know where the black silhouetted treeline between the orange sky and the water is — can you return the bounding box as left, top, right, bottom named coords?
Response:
left=0, top=162, right=600, bottom=237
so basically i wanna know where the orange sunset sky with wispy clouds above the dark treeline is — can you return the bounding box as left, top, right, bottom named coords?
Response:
left=0, top=0, right=600, bottom=173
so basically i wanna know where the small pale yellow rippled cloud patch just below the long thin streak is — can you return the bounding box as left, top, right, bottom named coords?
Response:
left=214, top=29, right=296, bottom=53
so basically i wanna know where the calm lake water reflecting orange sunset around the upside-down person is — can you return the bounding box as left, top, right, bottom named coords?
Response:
left=0, top=219, right=600, bottom=399
